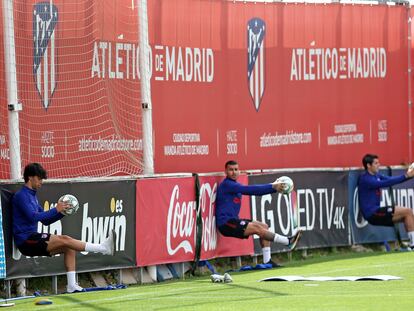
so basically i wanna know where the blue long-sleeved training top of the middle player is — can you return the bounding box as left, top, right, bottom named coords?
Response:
left=216, top=178, right=276, bottom=227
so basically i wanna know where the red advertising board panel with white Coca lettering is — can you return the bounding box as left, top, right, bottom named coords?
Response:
left=136, top=177, right=196, bottom=266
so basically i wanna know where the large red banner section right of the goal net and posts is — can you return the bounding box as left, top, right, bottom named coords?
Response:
left=149, top=0, right=410, bottom=172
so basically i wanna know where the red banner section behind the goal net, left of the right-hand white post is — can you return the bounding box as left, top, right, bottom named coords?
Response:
left=0, top=0, right=142, bottom=178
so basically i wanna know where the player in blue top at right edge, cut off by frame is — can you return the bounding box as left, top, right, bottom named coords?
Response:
left=358, top=154, right=414, bottom=250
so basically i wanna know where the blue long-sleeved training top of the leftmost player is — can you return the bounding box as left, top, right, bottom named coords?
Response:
left=12, top=186, right=64, bottom=246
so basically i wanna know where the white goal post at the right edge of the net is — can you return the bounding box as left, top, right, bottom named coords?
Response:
left=137, top=0, right=154, bottom=174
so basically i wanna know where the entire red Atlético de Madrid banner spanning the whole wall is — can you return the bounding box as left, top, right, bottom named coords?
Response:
left=0, top=0, right=413, bottom=178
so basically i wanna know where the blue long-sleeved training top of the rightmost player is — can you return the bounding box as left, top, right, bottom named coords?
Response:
left=358, top=171, right=408, bottom=218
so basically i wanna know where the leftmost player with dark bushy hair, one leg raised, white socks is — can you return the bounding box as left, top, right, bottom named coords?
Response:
left=12, top=163, right=116, bottom=293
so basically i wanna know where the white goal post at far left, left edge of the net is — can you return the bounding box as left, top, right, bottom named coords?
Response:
left=3, top=0, right=22, bottom=179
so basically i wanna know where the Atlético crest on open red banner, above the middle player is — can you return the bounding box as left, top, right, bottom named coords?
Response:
left=247, top=18, right=266, bottom=111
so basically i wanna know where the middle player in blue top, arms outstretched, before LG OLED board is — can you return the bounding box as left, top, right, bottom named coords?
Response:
left=216, top=160, right=302, bottom=267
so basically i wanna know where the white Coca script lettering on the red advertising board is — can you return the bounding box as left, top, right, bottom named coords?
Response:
left=167, top=185, right=196, bottom=255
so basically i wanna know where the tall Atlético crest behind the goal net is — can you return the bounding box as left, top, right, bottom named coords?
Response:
left=33, top=2, right=58, bottom=109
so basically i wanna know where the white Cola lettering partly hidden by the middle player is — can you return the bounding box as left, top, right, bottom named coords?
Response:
left=200, top=183, right=217, bottom=251
